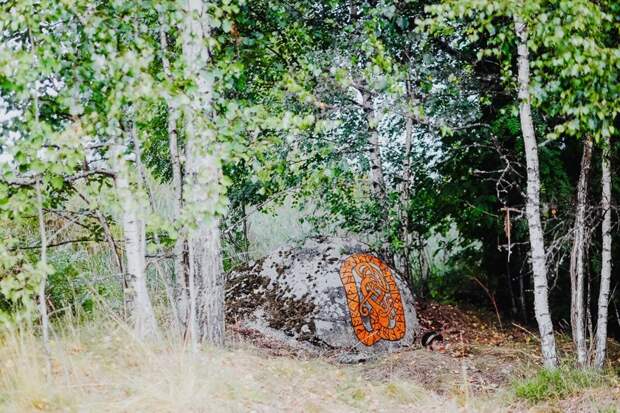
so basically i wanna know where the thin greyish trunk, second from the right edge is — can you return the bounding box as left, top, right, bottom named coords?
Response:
left=570, top=136, right=592, bottom=367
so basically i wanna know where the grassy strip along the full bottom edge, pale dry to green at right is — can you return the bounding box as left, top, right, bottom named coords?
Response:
left=0, top=321, right=620, bottom=412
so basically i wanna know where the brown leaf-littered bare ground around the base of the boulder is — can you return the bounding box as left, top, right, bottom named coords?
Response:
left=229, top=302, right=538, bottom=394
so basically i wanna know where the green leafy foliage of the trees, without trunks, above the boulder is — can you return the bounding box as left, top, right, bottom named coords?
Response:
left=0, top=0, right=620, bottom=358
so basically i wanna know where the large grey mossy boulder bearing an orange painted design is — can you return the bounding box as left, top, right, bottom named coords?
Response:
left=226, top=238, right=419, bottom=354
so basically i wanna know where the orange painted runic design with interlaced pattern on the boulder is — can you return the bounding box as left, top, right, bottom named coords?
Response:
left=340, top=254, right=406, bottom=346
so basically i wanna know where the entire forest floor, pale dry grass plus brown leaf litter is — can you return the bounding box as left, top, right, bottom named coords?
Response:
left=0, top=303, right=620, bottom=412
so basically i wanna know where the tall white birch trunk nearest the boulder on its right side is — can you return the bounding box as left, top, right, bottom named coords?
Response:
left=514, top=14, right=557, bottom=368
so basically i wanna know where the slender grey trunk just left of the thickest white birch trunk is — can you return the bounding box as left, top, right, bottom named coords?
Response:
left=159, top=13, right=189, bottom=328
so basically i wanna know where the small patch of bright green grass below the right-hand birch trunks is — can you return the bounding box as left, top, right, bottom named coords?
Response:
left=514, top=367, right=608, bottom=403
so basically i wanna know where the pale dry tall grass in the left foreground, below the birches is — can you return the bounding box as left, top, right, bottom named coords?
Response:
left=0, top=317, right=457, bottom=412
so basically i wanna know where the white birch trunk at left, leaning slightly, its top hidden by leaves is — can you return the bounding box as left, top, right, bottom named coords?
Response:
left=110, top=142, right=158, bottom=340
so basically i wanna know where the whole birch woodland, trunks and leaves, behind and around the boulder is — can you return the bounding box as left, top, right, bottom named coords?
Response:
left=0, top=0, right=620, bottom=408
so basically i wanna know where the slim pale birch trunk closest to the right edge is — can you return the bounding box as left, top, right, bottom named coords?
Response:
left=594, top=139, right=611, bottom=369
